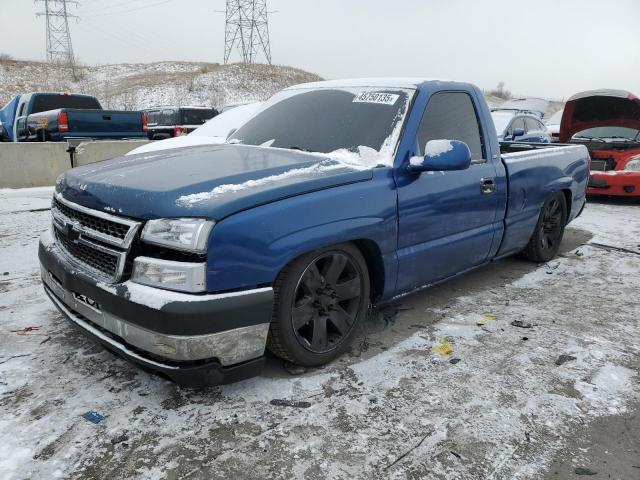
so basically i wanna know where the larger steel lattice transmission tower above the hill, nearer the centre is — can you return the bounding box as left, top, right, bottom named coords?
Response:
left=224, top=0, right=271, bottom=64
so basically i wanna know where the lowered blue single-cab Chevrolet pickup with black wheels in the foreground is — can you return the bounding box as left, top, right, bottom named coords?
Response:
left=39, top=79, right=589, bottom=385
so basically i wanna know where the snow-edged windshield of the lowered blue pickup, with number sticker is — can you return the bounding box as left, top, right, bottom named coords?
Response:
left=229, top=88, right=413, bottom=157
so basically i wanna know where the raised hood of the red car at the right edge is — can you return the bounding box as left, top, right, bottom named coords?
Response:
left=560, top=90, right=640, bottom=143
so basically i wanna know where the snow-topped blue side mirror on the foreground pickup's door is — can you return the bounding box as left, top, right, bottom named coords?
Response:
left=407, top=140, right=471, bottom=172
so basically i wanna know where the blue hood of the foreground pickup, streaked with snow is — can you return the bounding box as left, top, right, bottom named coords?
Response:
left=56, top=144, right=373, bottom=220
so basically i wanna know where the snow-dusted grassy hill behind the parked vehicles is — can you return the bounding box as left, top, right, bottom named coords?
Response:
left=0, top=57, right=321, bottom=109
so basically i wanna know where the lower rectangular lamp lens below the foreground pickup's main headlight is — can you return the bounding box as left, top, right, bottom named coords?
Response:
left=131, top=257, right=207, bottom=293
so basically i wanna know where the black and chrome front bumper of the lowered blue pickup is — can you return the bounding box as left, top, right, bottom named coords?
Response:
left=39, top=232, right=273, bottom=386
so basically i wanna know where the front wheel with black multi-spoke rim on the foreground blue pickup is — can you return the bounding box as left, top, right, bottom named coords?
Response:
left=267, top=243, right=370, bottom=367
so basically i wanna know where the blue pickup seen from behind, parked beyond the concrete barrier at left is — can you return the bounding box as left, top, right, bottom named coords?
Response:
left=0, top=92, right=147, bottom=142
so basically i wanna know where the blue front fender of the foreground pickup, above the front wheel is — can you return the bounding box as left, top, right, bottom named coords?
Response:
left=207, top=168, right=397, bottom=294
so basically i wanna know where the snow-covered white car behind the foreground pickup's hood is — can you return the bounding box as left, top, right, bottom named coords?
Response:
left=127, top=102, right=262, bottom=155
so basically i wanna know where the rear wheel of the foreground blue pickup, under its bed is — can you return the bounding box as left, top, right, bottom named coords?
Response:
left=522, top=192, right=567, bottom=263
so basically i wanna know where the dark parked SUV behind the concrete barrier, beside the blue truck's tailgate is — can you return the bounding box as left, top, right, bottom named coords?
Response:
left=144, top=106, right=219, bottom=140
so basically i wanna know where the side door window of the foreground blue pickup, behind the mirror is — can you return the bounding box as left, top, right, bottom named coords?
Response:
left=418, top=92, right=486, bottom=161
